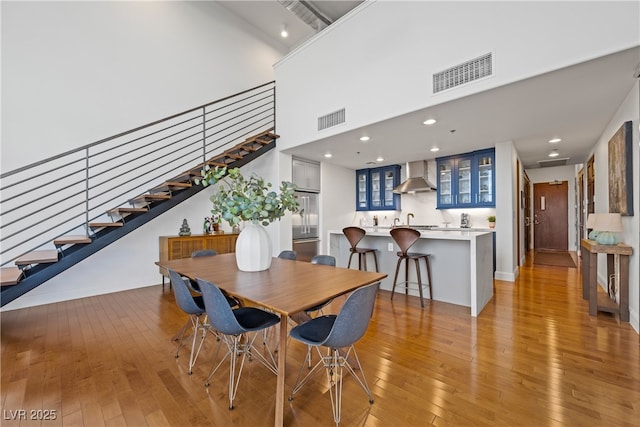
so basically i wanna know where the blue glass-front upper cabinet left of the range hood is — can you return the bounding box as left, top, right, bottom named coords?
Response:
left=356, top=165, right=400, bottom=211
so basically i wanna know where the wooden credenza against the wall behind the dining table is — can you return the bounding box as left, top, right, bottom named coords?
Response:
left=159, top=233, right=238, bottom=285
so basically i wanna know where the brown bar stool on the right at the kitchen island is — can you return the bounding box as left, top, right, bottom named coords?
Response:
left=391, top=227, right=433, bottom=307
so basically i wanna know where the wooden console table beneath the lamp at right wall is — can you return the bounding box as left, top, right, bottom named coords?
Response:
left=580, top=239, right=633, bottom=322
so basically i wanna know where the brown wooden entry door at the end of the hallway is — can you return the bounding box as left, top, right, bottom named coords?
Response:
left=533, top=181, right=569, bottom=251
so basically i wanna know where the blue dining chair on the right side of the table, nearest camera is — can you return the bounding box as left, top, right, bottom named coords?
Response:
left=289, top=283, right=380, bottom=425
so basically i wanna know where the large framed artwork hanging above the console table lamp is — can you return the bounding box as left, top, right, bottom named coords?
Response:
left=608, top=121, right=633, bottom=216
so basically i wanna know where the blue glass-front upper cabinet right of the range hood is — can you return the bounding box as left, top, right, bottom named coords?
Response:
left=436, top=149, right=496, bottom=209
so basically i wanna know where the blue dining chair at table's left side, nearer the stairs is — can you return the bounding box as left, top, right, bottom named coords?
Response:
left=167, top=269, right=214, bottom=375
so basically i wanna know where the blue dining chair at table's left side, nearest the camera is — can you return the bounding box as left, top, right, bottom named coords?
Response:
left=197, top=279, right=280, bottom=409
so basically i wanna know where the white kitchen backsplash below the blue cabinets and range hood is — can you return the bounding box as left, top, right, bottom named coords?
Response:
left=352, top=192, right=500, bottom=228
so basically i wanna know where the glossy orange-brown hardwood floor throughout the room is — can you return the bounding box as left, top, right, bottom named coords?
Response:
left=1, top=254, right=640, bottom=426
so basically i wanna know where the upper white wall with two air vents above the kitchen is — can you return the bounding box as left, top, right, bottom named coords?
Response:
left=275, top=1, right=638, bottom=152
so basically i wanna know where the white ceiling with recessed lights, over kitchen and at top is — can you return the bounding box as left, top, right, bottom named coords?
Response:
left=220, top=0, right=640, bottom=169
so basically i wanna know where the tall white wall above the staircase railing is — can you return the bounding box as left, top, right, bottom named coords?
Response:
left=1, top=1, right=282, bottom=172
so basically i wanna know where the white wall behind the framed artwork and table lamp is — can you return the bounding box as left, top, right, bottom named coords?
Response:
left=593, top=82, right=640, bottom=332
